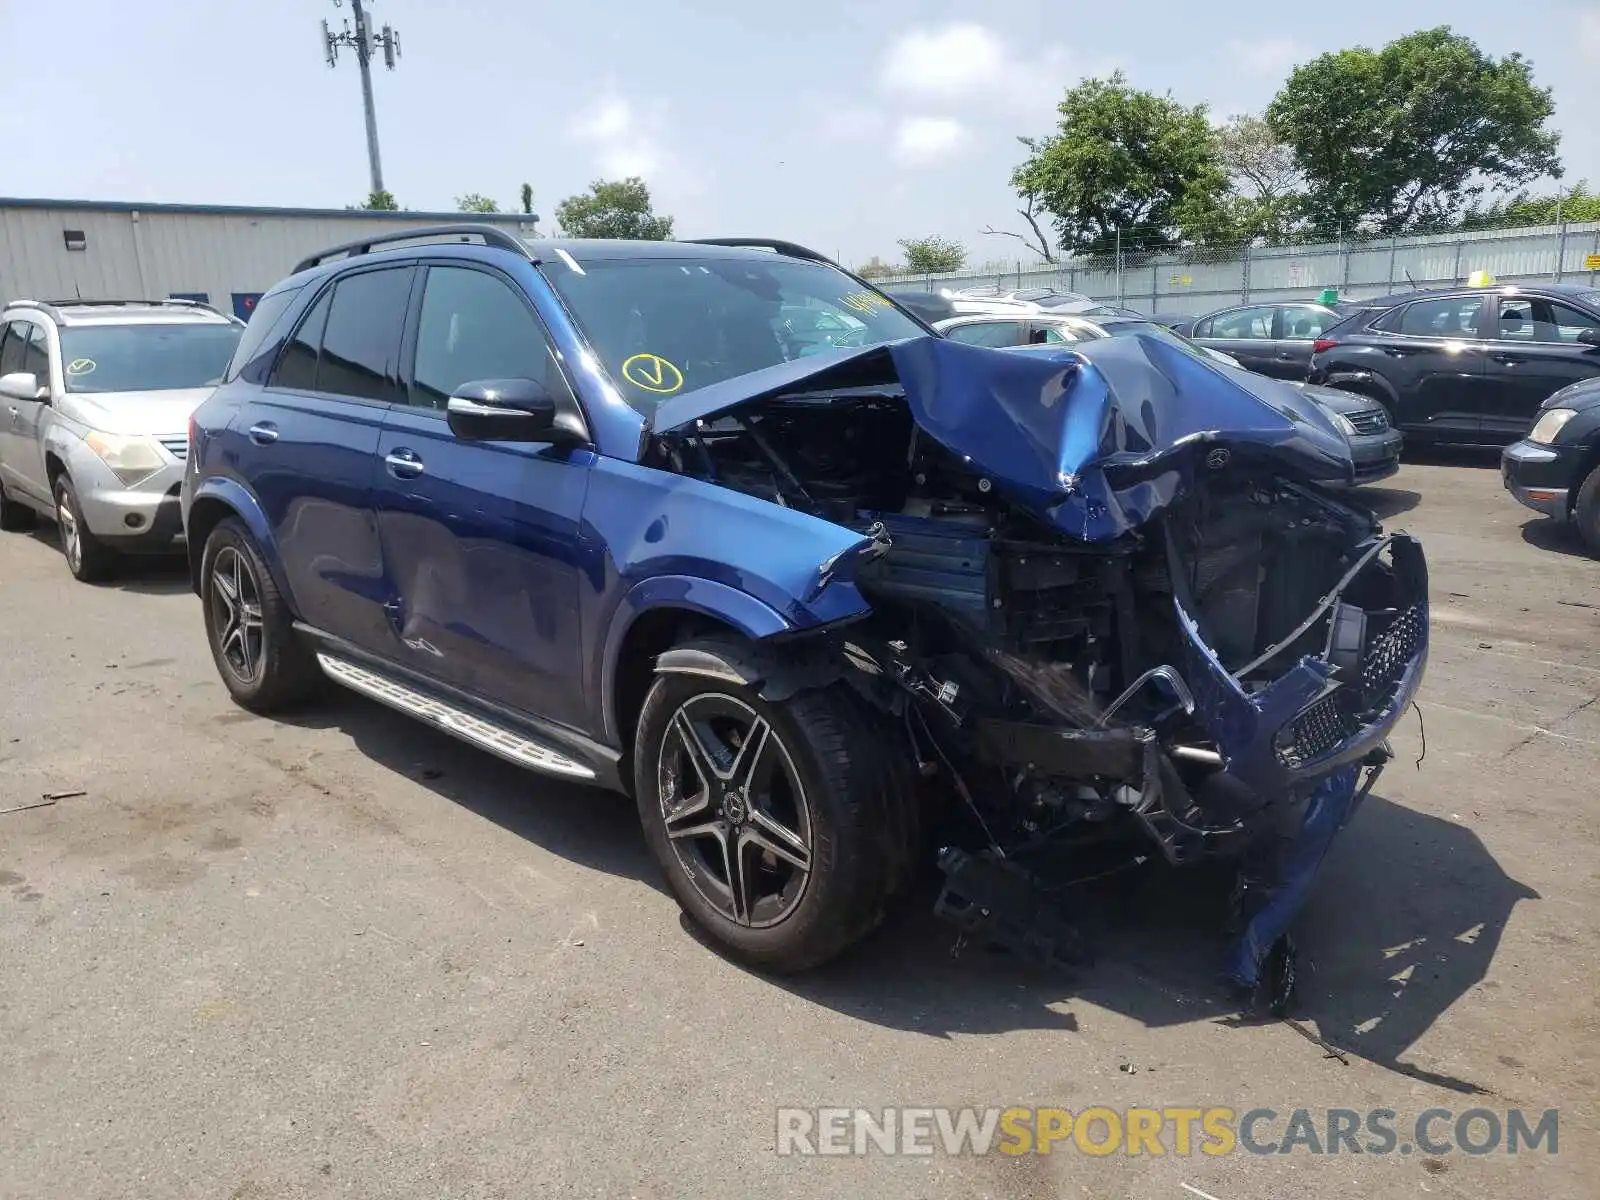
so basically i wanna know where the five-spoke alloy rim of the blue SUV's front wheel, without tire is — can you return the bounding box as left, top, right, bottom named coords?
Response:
left=656, top=693, right=813, bottom=928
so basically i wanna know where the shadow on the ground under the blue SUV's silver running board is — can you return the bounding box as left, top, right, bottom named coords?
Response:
left=275, top=690, right=659, bottom=904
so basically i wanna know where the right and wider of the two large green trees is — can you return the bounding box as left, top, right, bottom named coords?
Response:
left=1267, top=26, right=1562, bottom=235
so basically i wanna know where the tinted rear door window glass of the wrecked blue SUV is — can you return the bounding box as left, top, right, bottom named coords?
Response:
left=317, top=267, right=414, bottom=400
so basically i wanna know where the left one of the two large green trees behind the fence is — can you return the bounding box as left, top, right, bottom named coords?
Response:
left=1011, top=70, right=1227, bottom=254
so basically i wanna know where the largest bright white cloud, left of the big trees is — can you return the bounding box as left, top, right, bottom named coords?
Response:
left=882, top=21, right=1096, bottom=118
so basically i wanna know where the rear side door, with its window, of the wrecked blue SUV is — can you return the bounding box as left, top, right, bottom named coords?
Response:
left=229, top=266, right=418, bottom=658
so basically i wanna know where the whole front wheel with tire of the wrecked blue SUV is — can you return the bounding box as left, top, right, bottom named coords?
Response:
left=634, top=640, right=910, bottom=973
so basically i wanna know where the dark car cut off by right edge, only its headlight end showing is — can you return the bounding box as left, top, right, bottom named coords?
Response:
left=1501, top=378, right=1600, bottom=555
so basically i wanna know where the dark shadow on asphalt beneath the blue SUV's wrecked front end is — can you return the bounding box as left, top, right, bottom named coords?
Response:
left=755, top=797, right=1538, bottom=1093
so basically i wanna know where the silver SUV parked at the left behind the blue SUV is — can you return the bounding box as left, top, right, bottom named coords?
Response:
left=0, top=301, right=245, bottom=581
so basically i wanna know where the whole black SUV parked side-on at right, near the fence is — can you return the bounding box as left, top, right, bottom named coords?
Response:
left=1309, top=285, right=1600, bottom=446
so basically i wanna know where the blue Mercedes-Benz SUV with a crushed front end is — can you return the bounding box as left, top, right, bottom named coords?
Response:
left=182, top=226, right=1427, bottom=989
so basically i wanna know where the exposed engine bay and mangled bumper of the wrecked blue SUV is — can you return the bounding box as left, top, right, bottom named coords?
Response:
left=653, top=342, right=1427, bottom=1011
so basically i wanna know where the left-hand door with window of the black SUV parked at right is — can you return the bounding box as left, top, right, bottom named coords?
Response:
left=1368, top=293, right=1490, bottom=442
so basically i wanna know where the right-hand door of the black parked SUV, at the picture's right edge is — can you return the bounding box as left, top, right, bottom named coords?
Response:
left=1482, top=296, right=1600, bottom=443
